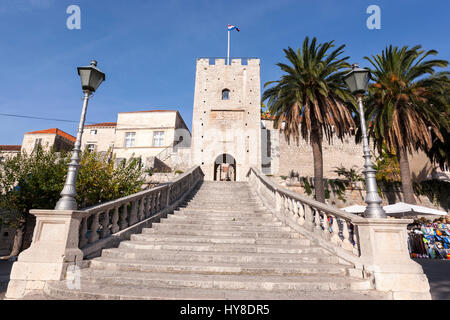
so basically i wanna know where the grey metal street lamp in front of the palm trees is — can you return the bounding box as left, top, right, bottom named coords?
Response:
left=344, top=63, right=386, bottom=218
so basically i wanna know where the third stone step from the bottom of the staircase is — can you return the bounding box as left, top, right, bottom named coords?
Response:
left=91, top=257, right=348, bottom=276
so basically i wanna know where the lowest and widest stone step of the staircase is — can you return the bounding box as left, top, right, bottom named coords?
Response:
left=40, top=281, right=388, bottom=302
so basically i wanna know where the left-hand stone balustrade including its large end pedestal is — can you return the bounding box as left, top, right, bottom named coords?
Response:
left=6, top=166, right=204, bottom=299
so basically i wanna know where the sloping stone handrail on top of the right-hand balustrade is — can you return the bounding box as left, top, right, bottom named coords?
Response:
left=250, top=167, right=366, bottom=222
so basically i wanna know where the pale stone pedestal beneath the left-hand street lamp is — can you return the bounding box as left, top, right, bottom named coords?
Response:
left=6, top=210, right=83, bottom=299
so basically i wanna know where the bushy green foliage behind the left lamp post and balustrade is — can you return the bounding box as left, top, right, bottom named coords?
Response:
left=0, top=146, right=143, bottom=256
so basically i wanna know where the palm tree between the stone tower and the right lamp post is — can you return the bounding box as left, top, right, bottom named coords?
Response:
left=262, top=37, right=355, bottom=202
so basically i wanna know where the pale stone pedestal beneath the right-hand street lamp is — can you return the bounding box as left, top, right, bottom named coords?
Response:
left=354, top=219, right=431, bottom=300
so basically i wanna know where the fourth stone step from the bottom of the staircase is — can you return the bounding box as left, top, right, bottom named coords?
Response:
left=102, top=248, right=339, bottom=264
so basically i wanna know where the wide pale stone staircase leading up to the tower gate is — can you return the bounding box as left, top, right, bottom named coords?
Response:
left=41, top=181, right=385, bottom=300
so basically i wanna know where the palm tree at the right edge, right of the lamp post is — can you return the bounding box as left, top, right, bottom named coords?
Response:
left=365, top=46, right=449, bottom=204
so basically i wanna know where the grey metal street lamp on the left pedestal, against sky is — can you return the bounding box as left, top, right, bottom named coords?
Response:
left=55, top=60, right=105, bottom=210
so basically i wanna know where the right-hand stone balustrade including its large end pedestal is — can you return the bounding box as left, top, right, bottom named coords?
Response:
left=247, top=168, right=431, bottom=299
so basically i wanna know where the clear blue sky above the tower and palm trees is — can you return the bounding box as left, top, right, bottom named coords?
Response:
left=0, top=0, right=450, bottom=144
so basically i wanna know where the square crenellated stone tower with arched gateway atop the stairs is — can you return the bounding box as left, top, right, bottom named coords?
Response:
left=191, top=58, right=261, bottom=181
